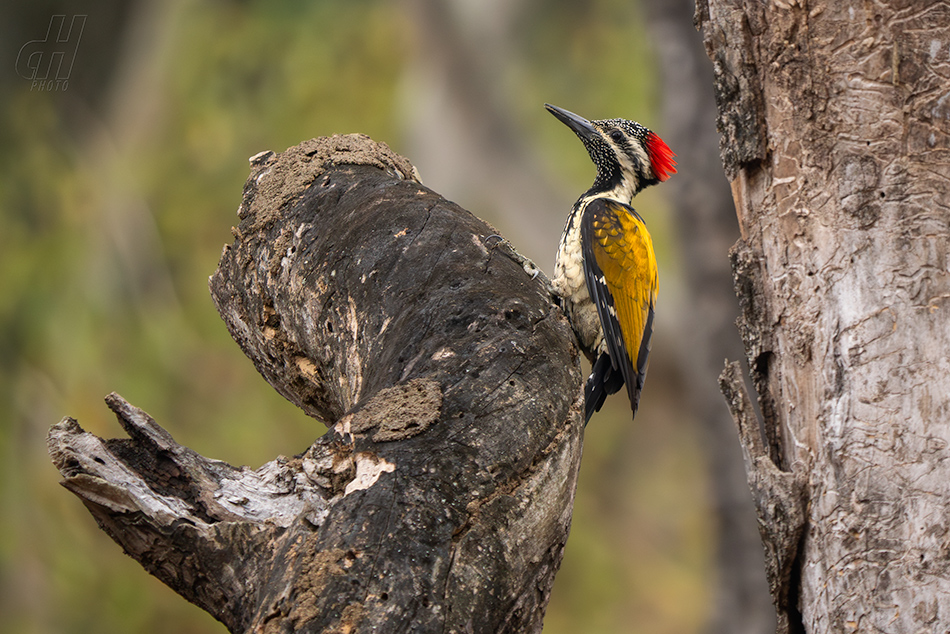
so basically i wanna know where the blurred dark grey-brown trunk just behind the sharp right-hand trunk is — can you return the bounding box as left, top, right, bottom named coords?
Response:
left=646, top=0, right=775, bottom=634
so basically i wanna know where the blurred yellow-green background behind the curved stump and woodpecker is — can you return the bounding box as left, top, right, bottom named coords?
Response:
left=0, top=0, right=713, bottom=634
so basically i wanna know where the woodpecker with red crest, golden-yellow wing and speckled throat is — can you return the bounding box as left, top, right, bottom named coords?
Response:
left=544, top=104, right=676, bottom=425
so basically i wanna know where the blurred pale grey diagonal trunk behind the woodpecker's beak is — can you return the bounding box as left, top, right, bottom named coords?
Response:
left=403, top=0, right=571, bottom=263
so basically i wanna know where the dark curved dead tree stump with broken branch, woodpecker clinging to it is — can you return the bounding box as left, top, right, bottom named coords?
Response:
left=49, top=135, right=582, bottom=633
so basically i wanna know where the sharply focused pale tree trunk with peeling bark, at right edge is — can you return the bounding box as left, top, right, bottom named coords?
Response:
left=697, top=0, right=950, bottom=633
